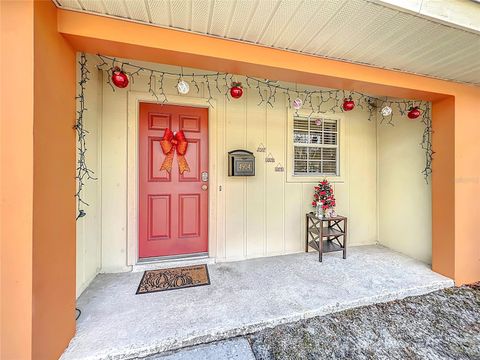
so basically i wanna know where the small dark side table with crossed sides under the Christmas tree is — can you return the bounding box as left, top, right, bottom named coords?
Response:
left=305, top=213, right=347, bottom=262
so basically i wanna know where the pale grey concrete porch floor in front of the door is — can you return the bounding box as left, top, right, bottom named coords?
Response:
left=62, top=246, right=454, bottom=360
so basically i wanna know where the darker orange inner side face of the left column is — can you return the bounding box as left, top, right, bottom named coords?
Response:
left=32, top=1, right=76, bottom=360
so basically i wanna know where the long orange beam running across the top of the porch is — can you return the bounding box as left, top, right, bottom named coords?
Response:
left=58, top=9, right=454, bottom=101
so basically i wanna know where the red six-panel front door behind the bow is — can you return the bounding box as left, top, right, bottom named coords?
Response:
left=139, top=103, right=208, bottom=258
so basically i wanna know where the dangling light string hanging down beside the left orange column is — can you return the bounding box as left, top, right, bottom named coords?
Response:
left=73, top=53, right=96, bottom=220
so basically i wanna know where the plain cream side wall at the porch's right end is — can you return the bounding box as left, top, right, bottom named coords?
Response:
left=377, top=111, right=432, bottom=264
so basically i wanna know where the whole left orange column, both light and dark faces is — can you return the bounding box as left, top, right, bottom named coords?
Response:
left=0, top=1, right=76, bottom=360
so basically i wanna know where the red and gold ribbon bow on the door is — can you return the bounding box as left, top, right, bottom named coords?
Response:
left=160, top=128, right=190, bottom=174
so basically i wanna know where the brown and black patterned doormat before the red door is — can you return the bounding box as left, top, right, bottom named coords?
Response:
left=137, top=264, right=210, bottom=295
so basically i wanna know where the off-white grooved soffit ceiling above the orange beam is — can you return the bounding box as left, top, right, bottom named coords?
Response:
left=54, top=0, right=480, bottom=85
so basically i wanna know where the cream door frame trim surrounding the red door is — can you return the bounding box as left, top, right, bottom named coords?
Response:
left=127, top=91, right=218, bottom=265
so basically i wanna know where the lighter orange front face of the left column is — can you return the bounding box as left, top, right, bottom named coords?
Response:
left=0, top=1, right=34, bottom=360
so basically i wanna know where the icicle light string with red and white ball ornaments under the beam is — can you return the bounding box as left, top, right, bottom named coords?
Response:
left=97, top=54, right=434, bottom=183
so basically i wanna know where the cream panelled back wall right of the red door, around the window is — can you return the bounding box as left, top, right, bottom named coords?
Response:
left=217, top=86, right=377, bottom=260
